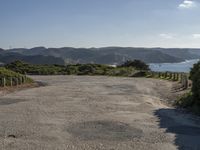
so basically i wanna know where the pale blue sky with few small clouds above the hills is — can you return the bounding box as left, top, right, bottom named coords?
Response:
left=0, top=0, right=200, bottom=49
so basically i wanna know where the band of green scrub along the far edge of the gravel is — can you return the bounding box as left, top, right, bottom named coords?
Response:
left=5, top=61, right=149, bottom=76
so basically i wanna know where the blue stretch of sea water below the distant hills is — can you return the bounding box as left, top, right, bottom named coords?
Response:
left=149, top=59, right=199, bottom=73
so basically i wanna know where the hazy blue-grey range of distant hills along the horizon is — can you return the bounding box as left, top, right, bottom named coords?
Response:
left=0, top=47, right=200, bottom=64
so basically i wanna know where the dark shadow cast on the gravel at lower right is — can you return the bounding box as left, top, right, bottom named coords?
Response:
left=155, top=109, right=200, bottom=150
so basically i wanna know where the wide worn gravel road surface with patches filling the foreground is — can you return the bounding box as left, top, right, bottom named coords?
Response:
left=0, top=76, right=200, bottom=150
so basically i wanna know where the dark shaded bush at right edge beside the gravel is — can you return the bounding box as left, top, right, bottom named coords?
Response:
left=176, top=62, right=200, bottom=115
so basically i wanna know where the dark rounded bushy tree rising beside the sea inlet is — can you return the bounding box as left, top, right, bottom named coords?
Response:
left=120, top=60, right=150, bottom=70
